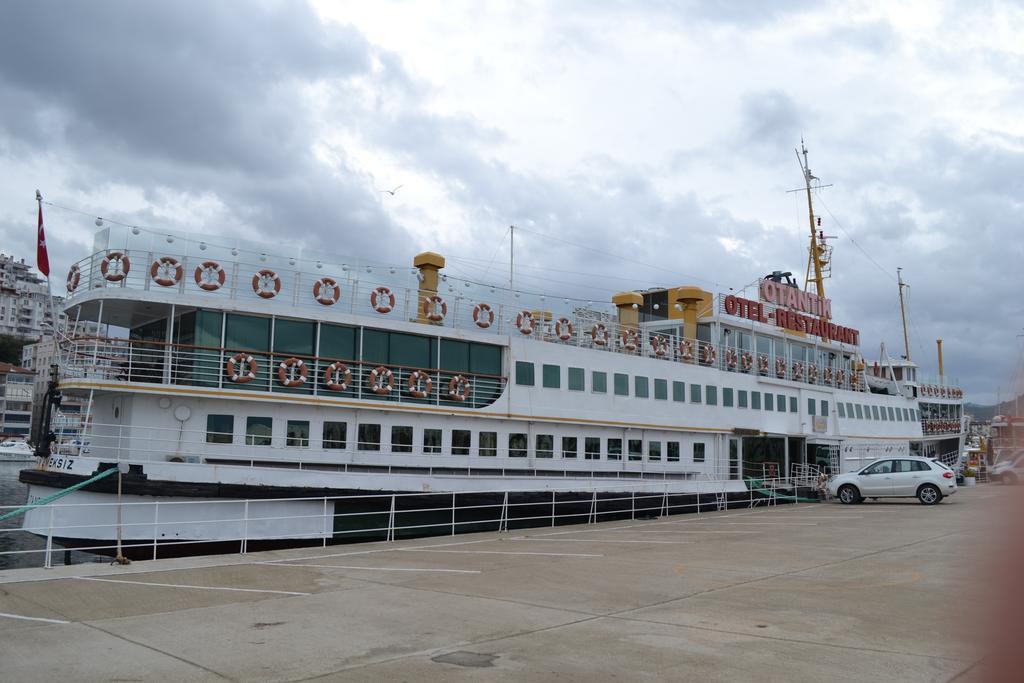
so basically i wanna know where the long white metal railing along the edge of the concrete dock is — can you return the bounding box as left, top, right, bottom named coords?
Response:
left=0, top=479, right=790, bottom=568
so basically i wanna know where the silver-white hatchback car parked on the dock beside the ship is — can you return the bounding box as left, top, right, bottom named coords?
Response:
left=828, top=456, right=956, bottom=505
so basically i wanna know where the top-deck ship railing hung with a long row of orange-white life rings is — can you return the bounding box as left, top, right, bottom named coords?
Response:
left=59, top=251, right=866, bottom=391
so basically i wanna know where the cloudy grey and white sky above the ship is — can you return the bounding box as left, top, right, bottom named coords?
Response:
left=0, top=0, right=1024, bottom=402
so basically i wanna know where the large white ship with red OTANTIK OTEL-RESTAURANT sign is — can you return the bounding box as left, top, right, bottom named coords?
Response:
left=20, top=148, right=964, bottom=543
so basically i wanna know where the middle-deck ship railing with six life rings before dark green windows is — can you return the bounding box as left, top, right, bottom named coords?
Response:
left=58, top=337, right=506, bottom=408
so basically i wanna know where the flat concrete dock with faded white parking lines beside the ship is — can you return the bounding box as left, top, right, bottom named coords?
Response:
left=0, top=486, right=1011, bottom=682
